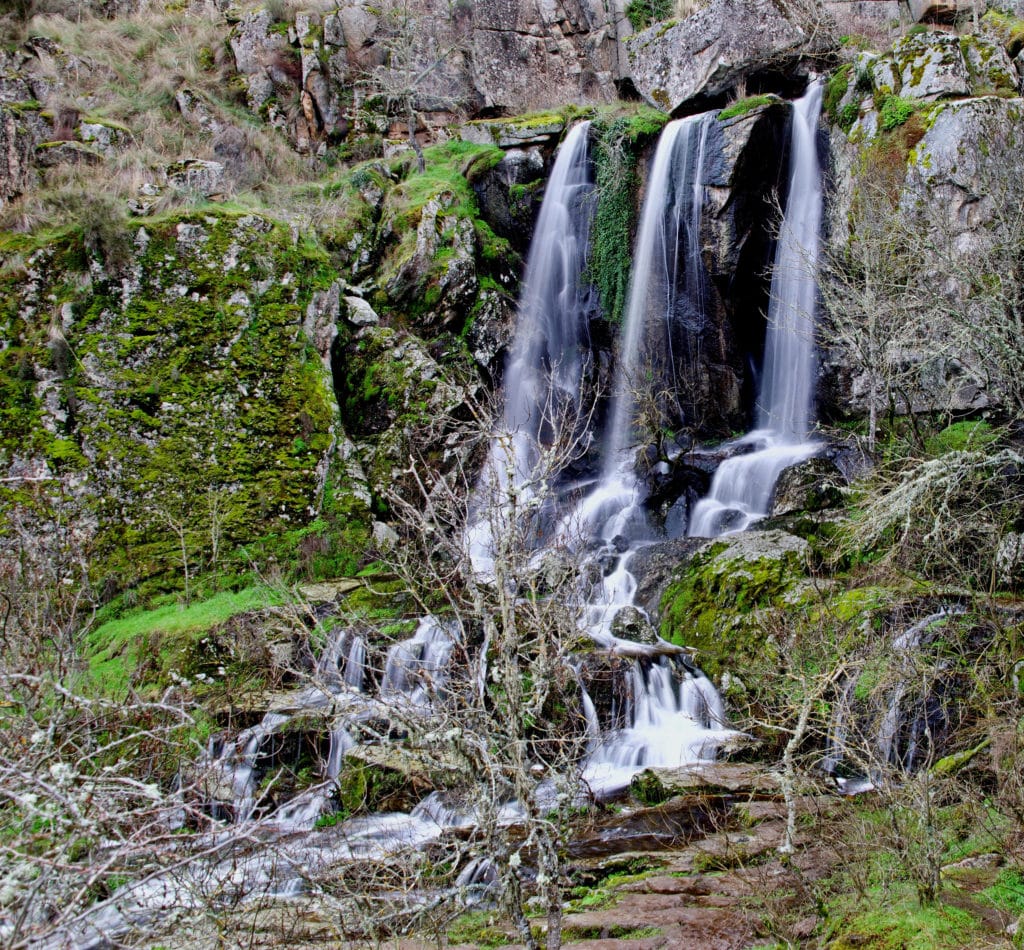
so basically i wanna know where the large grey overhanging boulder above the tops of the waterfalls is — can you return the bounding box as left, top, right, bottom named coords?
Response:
left=626, top=0, right=834, bottom=113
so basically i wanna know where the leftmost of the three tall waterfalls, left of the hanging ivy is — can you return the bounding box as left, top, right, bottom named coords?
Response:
left=466, top=122, right=596, bottom=575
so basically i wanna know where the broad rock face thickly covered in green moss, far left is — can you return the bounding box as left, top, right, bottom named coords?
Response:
left=0, top=210, right=368, bottom=588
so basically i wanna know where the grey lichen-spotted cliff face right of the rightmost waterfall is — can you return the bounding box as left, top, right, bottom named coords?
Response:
left=821, top=24, right=1024, bottom=415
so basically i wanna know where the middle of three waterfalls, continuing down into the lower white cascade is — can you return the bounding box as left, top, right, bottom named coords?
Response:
left=560, top=114, right=734, bottom=797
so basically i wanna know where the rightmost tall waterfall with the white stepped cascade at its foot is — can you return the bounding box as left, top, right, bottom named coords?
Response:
left=689, top=80, right=823, bottom=537
